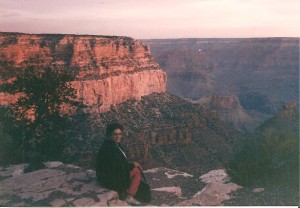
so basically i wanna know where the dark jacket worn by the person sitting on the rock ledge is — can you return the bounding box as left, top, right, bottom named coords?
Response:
left=96, top=139, right=134, bottom=193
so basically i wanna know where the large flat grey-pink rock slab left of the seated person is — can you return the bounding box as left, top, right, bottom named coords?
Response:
left=0, top=162, right=119, bottom=207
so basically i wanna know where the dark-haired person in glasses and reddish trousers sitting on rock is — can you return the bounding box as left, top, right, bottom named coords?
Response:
left=96, top=123, right=141, bottom=205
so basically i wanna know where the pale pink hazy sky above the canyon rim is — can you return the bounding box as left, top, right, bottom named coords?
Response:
left=0, top=0, right=300, bottom=39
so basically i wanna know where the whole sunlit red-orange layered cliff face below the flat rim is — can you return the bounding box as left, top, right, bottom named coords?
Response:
left=0, top=33, right=166, bottom=111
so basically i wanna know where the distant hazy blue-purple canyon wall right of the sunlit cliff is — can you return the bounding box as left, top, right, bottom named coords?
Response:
left=142, top=38, right=299, bottom=114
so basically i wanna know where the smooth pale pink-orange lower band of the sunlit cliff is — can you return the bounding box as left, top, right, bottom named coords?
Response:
left=72, top=70, right=166, bottom=112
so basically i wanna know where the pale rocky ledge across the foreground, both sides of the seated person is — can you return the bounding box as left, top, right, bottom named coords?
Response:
left=0, top=162, right=240, bottom=207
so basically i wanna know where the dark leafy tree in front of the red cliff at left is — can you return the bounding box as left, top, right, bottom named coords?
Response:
left=1, top=65, right=81, bottom=169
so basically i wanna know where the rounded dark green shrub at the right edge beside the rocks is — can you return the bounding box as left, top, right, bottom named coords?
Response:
left=226, top=129, right=299, bottom=186
